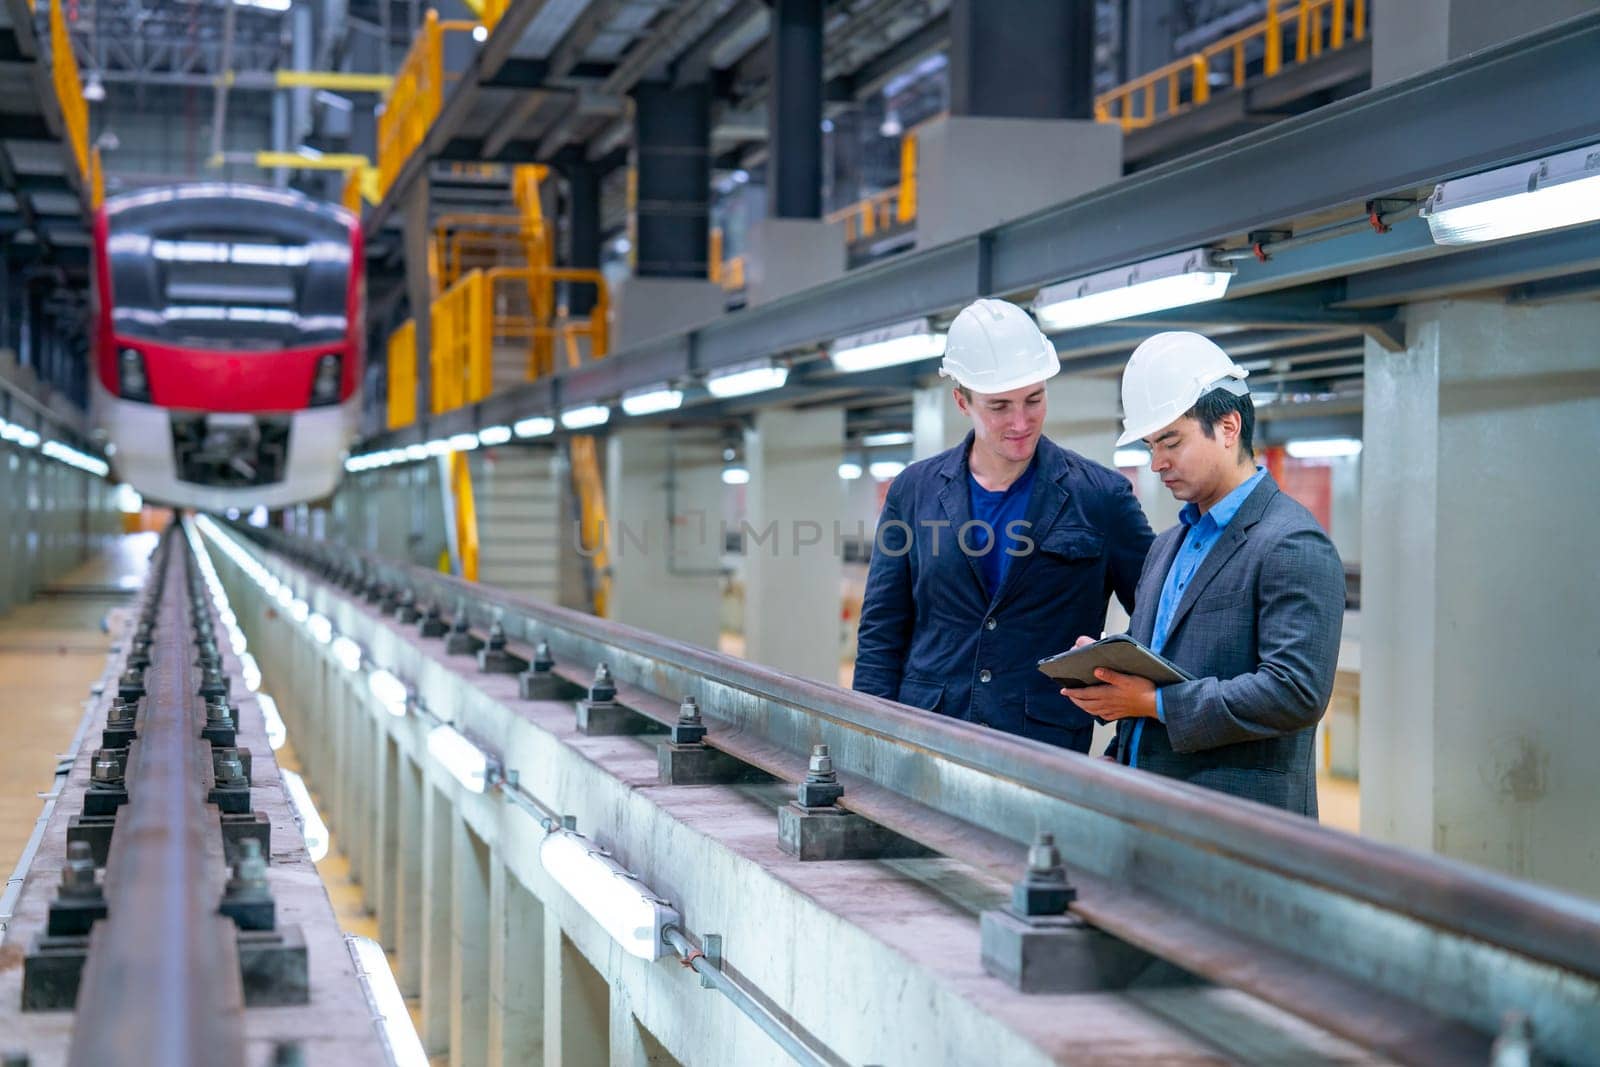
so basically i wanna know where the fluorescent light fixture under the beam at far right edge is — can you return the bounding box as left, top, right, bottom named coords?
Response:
left=1422, top=144, right=1600, bottom=245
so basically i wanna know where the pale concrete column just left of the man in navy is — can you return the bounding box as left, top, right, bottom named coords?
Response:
left=744, top=408, right=845, bottom=685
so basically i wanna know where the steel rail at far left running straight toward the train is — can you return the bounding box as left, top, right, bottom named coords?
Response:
left=67, top=530, right=245, bottom=1067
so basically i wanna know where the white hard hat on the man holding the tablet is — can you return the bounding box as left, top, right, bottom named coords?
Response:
left=1117, top=331, right=1250, bottom=448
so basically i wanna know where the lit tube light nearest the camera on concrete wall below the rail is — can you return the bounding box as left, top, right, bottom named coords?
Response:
left=539, top=830, right=678, bottom=960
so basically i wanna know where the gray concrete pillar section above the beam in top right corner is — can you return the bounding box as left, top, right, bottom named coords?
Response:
left=1368, top=0, right=1595, bottom=88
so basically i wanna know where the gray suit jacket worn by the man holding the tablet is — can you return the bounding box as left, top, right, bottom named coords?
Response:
left=1114, top=475, right=1344, bottom=817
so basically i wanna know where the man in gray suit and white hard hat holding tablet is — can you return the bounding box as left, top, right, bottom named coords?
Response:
left=1062, top=333, right=1344, bottom=817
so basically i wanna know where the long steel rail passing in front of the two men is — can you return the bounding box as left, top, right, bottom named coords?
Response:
left=228, top=531, right=1600, bottom=1062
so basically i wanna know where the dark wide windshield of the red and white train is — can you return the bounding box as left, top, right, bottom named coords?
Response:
left=106, top=197, right=350, bottom=352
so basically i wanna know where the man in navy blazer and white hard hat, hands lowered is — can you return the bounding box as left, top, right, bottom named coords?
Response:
left=854, top=299, right=1152, bottom=752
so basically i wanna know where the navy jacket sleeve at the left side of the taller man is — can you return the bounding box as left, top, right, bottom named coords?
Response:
left=851, top=480, right=915, bottom=701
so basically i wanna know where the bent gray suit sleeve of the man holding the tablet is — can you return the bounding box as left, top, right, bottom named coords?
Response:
left=1162, top=530, right=1344, bottom=752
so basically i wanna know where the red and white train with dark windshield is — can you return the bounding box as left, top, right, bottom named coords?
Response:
left=93, top=184, right=365, bottom=512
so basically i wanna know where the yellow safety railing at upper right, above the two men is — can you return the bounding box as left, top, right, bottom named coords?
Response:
left=1094, top=0, right=1366, bottom=131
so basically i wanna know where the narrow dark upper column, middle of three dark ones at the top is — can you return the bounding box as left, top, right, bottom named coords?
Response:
left=766, top=0, right=822, bottom=219
